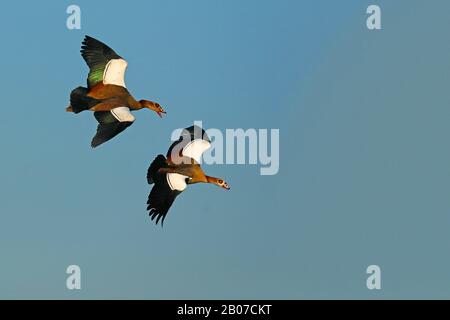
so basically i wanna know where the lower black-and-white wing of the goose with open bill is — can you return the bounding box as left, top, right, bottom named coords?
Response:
left=91, top=107, right=135, bottom=148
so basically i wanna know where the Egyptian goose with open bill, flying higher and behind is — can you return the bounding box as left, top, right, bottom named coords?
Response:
left=66, top=36, right=166, bottom=148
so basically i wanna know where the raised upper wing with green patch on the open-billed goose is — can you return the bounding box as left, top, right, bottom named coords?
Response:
left=81, top=36, right=128, bottom=88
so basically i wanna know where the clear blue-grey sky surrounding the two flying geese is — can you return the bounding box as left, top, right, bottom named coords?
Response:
left=0, top=0, right=450, bottom=299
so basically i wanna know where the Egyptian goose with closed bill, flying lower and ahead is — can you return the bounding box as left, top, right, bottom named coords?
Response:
left=147, top=126, right=230, bottom=225
